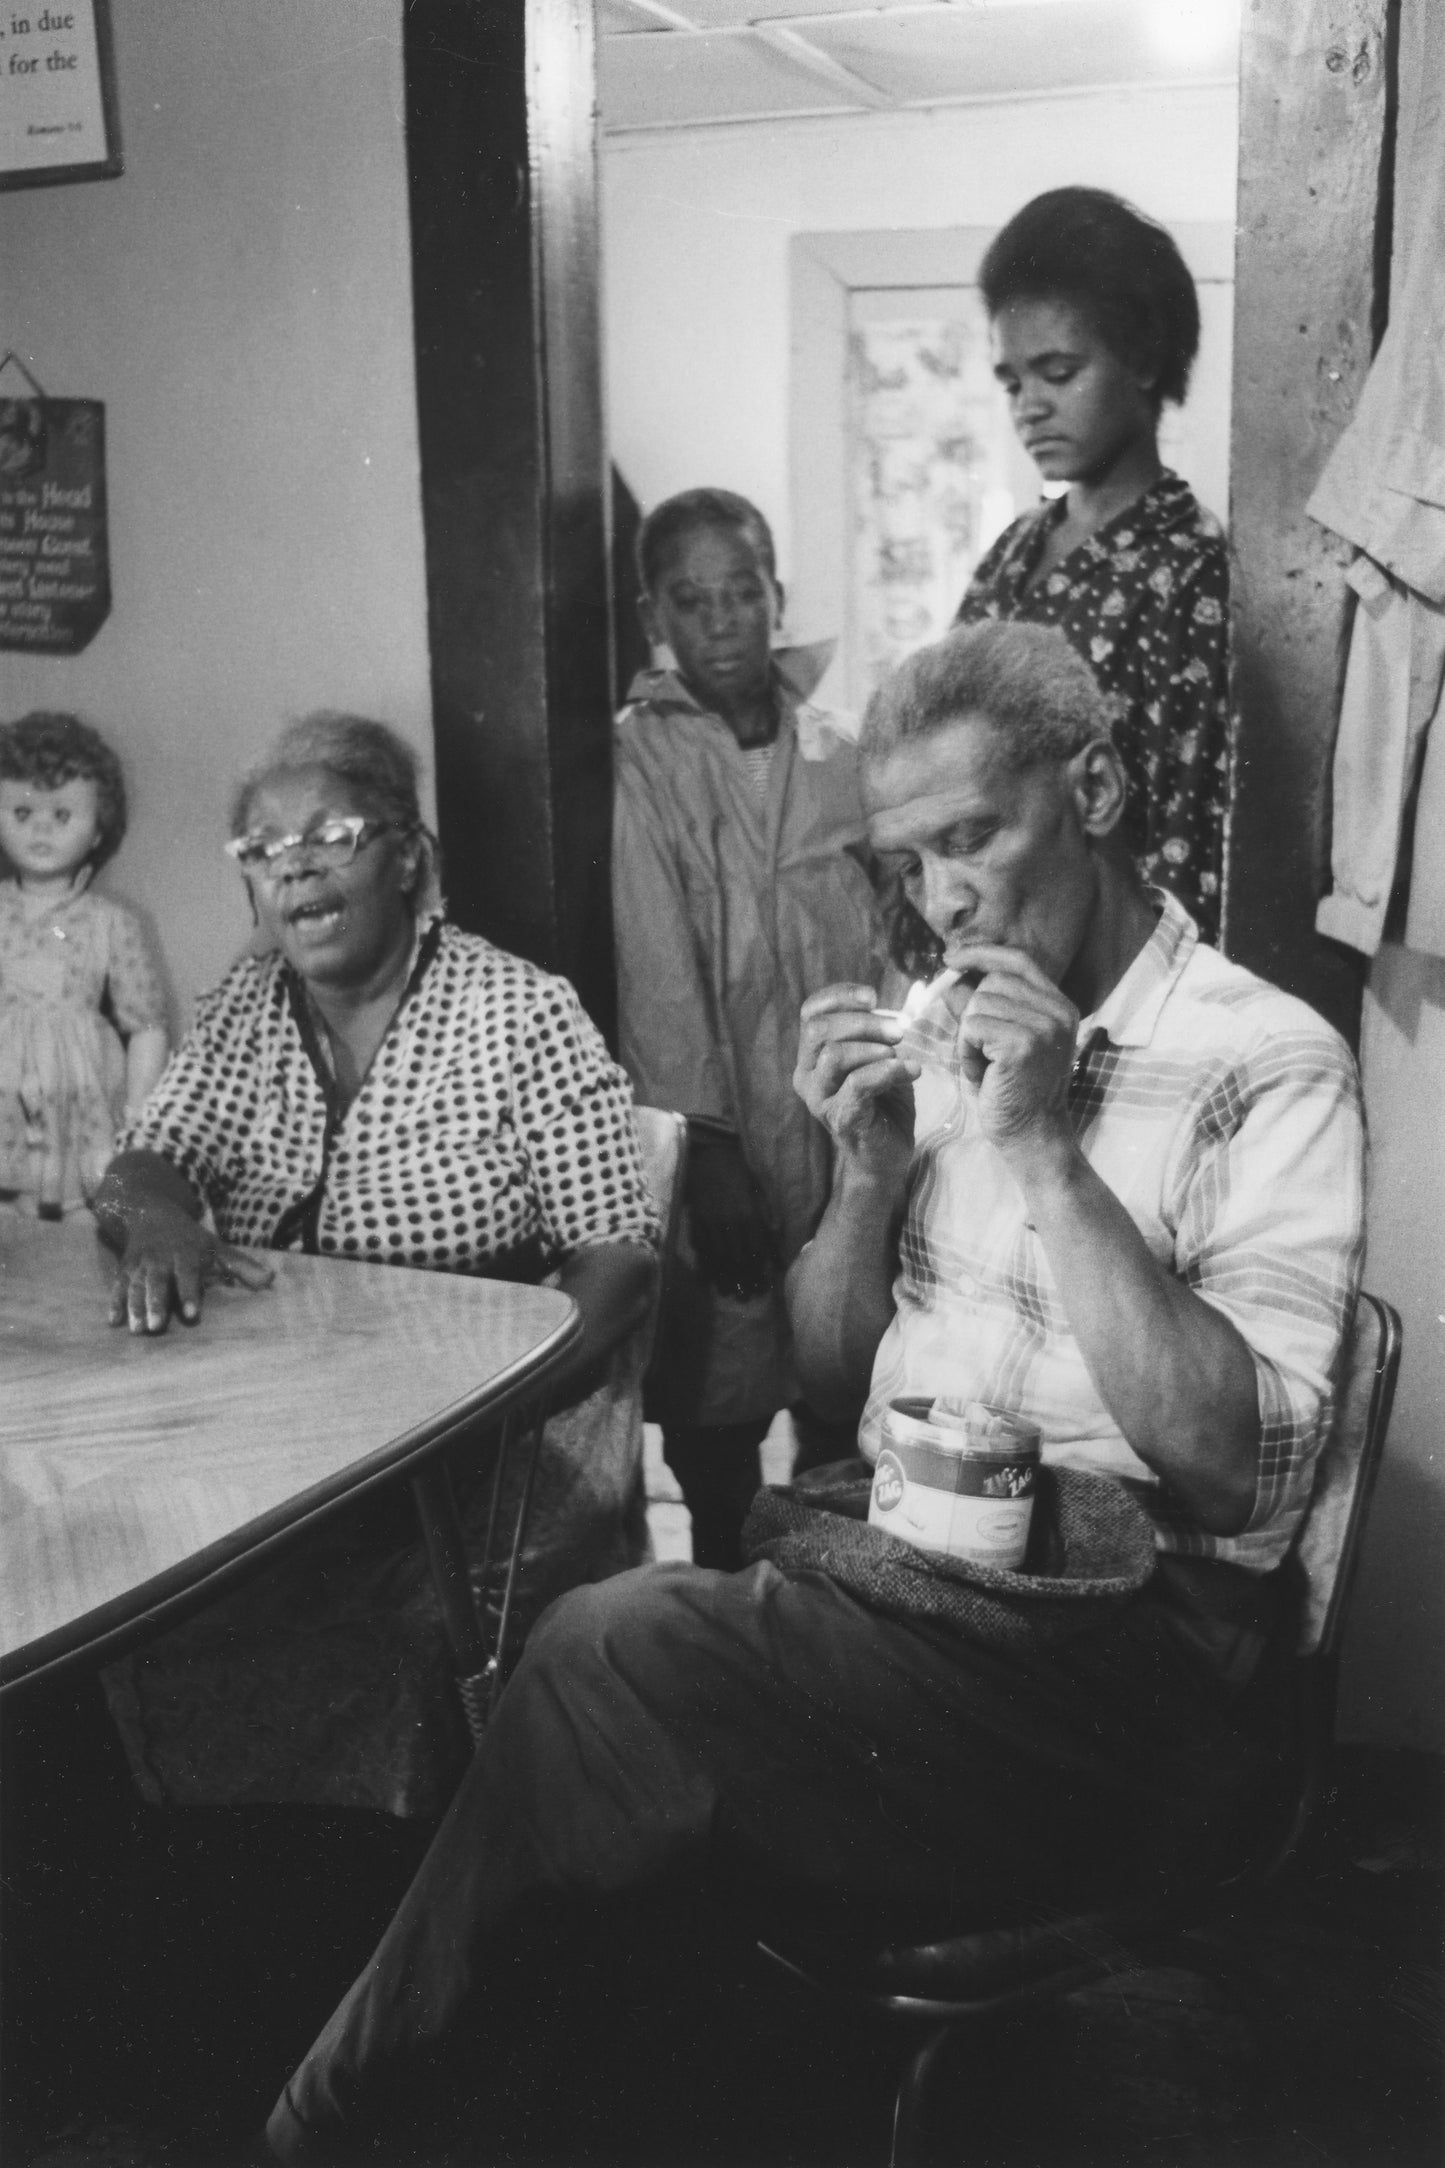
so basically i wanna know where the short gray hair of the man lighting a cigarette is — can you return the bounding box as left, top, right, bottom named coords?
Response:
left=860, top=618, right=1111, bottom=767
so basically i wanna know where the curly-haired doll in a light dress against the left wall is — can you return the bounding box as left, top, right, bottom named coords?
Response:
left=0, top=713, right=169, bottom=1218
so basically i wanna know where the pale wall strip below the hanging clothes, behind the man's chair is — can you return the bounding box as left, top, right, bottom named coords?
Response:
left=1341, top=943, right=1445, bottom=1752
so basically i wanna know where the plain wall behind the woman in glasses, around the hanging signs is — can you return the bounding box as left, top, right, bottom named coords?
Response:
left=0, top=0, right=431, bottom=1021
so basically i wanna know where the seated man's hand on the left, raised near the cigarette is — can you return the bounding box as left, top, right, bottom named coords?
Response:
left=793, top=986, right=919, bottom=1184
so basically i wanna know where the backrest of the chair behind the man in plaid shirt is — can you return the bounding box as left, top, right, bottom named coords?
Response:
left=1296, top=1292, right=1402, bottom=1656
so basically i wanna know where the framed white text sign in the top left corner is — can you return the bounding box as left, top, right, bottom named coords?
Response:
left=0, top=0, right=121, bottom=189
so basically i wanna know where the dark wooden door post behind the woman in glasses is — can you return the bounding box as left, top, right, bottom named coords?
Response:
left=403, top=0, right=613, bottom=1032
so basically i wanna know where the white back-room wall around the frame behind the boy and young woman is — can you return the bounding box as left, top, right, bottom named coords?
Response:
left=602, top=85, right=1237, bottom=579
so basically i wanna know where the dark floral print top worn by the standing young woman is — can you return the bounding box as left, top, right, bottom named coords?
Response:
left=955, top=470, right=1228, bottom=941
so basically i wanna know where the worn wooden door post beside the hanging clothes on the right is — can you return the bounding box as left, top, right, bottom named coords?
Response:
left=1224, top=0, right=1389, bottom=1043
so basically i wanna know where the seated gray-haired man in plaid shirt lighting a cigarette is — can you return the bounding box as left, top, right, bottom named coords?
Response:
left=271, top=624, right=1363, bottom=2157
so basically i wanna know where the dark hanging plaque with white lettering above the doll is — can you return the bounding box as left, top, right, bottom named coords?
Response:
left=0, top=399, right=110, bottom=655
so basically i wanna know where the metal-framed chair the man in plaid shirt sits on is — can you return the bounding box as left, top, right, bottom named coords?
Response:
left=758, top=1294, right=1402, bottom=2168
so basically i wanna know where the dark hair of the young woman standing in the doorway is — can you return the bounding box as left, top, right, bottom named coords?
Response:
left=979, top=189, right=1200, bottom=408
